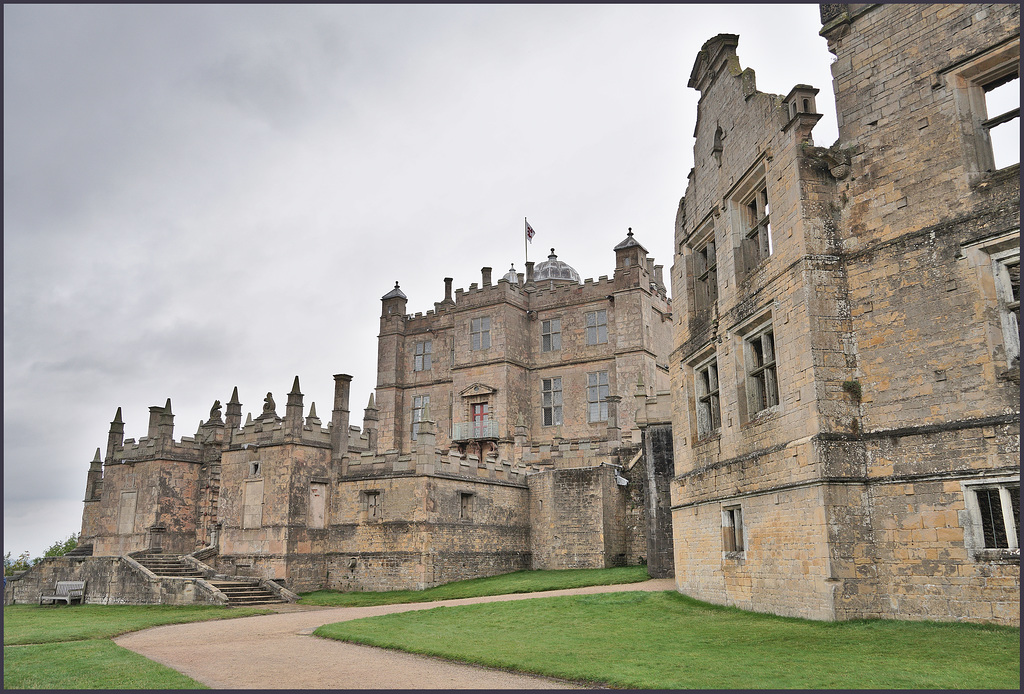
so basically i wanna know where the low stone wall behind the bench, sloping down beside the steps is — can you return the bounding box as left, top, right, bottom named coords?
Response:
left=4, top=557, right=222, bottom=605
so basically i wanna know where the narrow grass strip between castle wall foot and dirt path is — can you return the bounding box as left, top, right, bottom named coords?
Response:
left=299, top=566, right=650, bottom=607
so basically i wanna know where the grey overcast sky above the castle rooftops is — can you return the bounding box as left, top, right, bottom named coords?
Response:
left=4, top=4, right=837, bottom=557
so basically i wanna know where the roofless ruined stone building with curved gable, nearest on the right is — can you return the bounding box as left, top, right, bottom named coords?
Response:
left=648, top=4, right=1020, bottom=624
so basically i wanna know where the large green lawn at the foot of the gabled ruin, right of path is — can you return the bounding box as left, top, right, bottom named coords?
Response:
left=315, top=592, right=1020, bottom=690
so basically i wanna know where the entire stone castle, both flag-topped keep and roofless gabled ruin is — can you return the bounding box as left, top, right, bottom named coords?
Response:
left=5, top=4, right=1020, bottom=624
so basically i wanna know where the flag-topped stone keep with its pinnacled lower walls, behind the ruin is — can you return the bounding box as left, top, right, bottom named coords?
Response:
left=10, top=231, right=671, bottom=602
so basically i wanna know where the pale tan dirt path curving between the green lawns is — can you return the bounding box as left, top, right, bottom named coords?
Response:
left=114, top=578, right=675, bottom=689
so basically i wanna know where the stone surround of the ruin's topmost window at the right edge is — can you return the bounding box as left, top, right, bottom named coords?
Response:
left=932, top=35, right=1020, bottom=183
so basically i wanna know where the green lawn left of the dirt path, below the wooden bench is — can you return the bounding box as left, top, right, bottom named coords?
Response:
left=3, top=605, right=269, bottom=689
